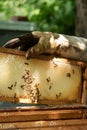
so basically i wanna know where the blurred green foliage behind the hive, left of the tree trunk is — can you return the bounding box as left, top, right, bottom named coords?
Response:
left=0, top=0, right=75, bottom=34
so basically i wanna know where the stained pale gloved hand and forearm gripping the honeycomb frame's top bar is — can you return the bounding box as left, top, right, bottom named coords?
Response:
left=3, top=31, right=87, bottom=62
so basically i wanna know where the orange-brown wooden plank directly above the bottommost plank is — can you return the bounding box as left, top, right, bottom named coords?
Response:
left=0, top=109, right=87, bottom=122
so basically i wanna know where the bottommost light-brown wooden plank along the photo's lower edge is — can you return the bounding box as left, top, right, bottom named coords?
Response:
left=0, top=119, right=87, bottom=130
